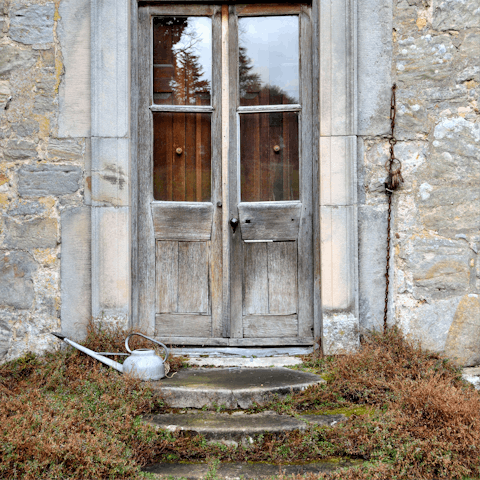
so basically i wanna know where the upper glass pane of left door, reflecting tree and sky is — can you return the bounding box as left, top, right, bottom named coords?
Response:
left=153, top=17, right=212, bottom=105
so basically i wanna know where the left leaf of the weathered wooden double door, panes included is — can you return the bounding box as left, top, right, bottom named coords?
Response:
left=136, top=5, right=223, bottom=344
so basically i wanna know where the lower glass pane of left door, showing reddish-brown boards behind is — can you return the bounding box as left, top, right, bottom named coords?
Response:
left=153, top=112, right=212, bottom=202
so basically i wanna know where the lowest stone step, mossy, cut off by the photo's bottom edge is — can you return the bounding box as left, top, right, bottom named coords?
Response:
left=143, top=461, right=359, bottom=480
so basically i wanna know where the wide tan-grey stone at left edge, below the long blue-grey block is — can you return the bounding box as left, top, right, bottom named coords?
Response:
left=5, top=218, right=57, bottom=249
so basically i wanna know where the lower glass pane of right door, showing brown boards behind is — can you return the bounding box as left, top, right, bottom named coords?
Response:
left=240, top=112, right=300, bottom=202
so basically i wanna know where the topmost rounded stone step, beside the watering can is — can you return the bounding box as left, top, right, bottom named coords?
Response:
left=152, top=367, right=324, bottom=410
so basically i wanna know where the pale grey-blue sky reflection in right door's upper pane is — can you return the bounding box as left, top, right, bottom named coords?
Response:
left=239, top=16, right=299, bottom=102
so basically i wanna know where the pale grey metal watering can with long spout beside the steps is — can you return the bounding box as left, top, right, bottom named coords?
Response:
left=52, top=332, right=169, bottom=380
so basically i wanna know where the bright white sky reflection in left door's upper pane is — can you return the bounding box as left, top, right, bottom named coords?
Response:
left=173, top=17, right=212, bottom=86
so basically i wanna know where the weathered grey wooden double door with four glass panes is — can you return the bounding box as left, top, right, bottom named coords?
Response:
left=135, top=4, right=314, bottom=346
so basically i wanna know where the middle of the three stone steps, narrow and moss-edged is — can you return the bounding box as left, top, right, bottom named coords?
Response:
left=144, top=411, right=347, bottom=445
